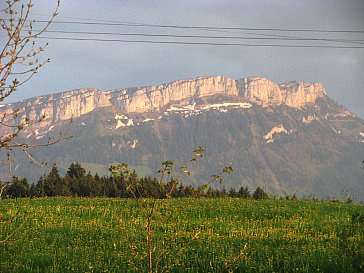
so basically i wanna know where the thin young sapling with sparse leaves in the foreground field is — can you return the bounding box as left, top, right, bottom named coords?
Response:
left=110, top=147, right=235, bottom=273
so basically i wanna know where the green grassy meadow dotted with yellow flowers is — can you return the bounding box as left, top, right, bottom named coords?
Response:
left=0, top=197, right=364, bottom=273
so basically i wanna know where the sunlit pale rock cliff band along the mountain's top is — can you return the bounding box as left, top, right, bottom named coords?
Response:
left=0, top=76, right=325, bottom=126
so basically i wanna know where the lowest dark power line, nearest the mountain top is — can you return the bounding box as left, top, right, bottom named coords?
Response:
left=38, top=36, right=364, bottom=49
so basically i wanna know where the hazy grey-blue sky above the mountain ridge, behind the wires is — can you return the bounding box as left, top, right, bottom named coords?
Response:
left=5, top=0, right=364, bottom=117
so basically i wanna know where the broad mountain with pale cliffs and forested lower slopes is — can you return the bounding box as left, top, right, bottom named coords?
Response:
left=0, top=76, right=364, bottom=199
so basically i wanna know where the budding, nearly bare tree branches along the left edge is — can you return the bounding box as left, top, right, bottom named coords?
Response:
left=0, top=0, right=61, bottom=199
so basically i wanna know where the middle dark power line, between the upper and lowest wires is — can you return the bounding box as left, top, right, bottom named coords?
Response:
left=29, top=30, right=364, bottom=44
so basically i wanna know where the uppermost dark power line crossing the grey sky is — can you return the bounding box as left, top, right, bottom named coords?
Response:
left=30, top=19, right=364, bottom=33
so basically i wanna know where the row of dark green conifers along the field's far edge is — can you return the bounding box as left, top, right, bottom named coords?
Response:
left=4, top=163, right=268, bottom=199
